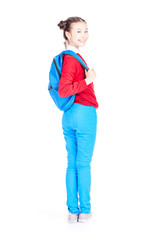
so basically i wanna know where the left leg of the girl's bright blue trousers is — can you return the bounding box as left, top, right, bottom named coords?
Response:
left=62, top=112, right=79, bottom=214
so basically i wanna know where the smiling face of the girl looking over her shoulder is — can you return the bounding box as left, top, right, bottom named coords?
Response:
left=66, top=22, right=88, bottom=49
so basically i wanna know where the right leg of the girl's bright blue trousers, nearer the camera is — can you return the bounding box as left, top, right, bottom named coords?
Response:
left=76, top=105, right=97, bottom=214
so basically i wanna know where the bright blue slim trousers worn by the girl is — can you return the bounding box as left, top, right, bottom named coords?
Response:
left=62, top=103, right=97, bottom=214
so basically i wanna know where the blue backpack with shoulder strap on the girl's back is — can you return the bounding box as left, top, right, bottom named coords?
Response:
left=48, top=50, right=88, bottom=111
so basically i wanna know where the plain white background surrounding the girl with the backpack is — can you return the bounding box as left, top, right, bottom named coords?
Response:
left=0, top=0, right=160, bottom=240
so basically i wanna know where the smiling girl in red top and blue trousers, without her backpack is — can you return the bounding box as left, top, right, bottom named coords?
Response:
left=58, top=17, right=98, bottom=223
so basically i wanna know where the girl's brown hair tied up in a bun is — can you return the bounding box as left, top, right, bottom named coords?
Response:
left=57, top=17, right=86, bottom=40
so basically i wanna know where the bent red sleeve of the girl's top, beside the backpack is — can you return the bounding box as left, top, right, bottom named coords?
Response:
left=58, top=55, right=87, bottom=98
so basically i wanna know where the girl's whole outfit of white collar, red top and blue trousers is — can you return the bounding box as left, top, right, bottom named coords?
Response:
left=59, top=46, right=98, bottom=214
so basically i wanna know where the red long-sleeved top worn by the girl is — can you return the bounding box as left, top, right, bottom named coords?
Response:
left=58, top=54, right=98, bottom=108
